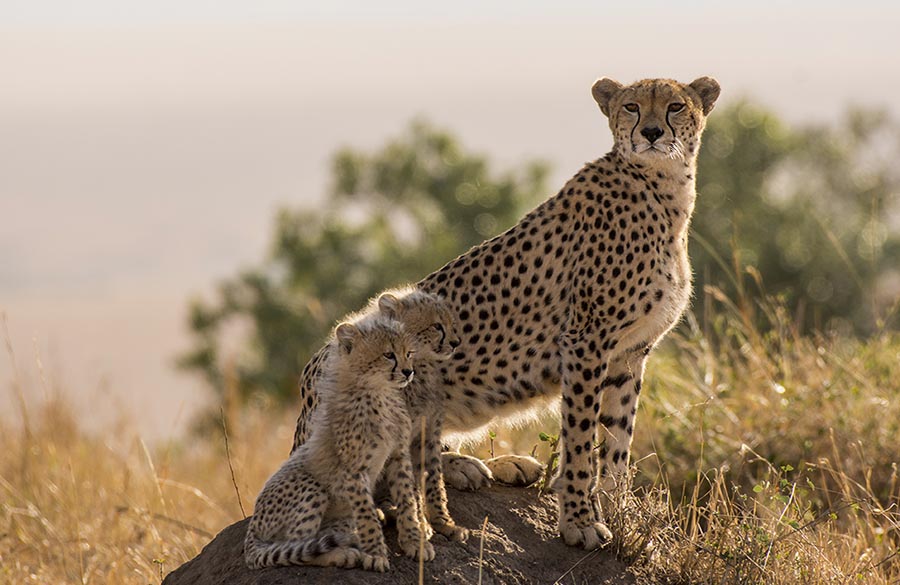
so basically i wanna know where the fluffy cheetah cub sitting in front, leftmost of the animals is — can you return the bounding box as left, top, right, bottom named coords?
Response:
left=244, top=318, right=418, bottom=572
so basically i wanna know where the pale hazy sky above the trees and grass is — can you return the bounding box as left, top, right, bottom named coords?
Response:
left=0, top=0, right=900, bottom=436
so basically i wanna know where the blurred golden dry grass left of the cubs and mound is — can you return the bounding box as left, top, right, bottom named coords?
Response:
left=0, top=368, right=295, bottom=584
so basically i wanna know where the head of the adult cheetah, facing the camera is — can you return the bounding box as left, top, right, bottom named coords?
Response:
left=591, top=77, right=719, bottom=166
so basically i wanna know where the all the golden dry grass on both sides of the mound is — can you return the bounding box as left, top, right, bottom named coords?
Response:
left=0, top=291, right=900, bottom=584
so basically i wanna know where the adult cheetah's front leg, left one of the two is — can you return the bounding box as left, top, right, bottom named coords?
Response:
left=552, top=331, right=612, bottom=550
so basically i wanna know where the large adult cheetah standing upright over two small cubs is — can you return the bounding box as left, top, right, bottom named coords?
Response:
left=295, top=77, right=719, bottom=549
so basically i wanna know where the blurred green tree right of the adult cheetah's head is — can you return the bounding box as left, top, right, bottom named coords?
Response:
left=691, top=102, right=900, bottom=333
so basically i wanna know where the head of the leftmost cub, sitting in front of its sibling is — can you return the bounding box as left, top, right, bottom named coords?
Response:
left=334, top=319, right=414, bottom=388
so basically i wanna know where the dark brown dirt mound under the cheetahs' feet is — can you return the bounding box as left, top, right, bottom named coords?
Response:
left=163, top=487, right=635, bottom=585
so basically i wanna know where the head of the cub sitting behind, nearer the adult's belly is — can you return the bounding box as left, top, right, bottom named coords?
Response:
left=378, top=288, right=459, bottom=359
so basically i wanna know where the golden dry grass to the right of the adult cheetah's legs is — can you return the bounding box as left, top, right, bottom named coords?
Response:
left=610, top=290, right=900, bottom=584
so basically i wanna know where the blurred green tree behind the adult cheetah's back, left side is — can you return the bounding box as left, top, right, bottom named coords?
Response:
left=179, top=122, right=547, bottom=400
